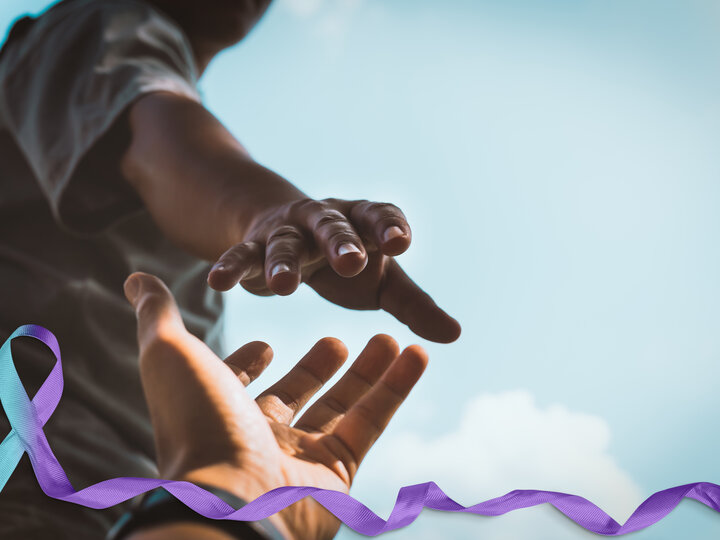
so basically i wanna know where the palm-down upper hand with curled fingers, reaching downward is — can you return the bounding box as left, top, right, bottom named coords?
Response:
left=208, top=199, right=460, bottom=343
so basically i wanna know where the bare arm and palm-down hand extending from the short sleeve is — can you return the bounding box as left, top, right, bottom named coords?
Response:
left=121, top=89, right=460, bottom=342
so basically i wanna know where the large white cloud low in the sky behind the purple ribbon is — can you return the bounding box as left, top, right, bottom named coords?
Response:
left=341, top=391, right=643, bottom=540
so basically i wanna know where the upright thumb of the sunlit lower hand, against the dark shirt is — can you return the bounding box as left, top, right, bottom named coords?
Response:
left=123, top=272, right=185, bottom=350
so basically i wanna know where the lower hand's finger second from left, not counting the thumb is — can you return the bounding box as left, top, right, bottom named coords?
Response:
left=257, top=338, right=347, bottom=424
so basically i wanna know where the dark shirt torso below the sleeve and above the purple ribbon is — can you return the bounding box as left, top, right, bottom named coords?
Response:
left=0, top=103, right=222, bottom=484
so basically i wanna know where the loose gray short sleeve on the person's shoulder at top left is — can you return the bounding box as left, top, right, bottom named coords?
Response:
left=0, top=0, right=200, bottom=233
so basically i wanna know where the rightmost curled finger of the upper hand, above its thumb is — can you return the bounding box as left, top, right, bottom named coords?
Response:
left=350, top=201, right=412, bottom=257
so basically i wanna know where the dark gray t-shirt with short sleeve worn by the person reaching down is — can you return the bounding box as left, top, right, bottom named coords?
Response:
left=0, top=0, right=222, bottom=538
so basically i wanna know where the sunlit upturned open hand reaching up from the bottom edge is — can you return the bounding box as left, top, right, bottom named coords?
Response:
left=125, top=273, right=427, bottom=540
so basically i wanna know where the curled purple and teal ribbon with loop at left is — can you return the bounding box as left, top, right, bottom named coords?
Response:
left=0, top=325, right=720, bottom=536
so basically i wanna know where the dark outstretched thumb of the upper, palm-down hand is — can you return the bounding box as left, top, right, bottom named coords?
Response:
left=380, top=260, right=461, bottom=343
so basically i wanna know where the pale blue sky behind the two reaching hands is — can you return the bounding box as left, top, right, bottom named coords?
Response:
left=0, top=0, right=720, bottom=540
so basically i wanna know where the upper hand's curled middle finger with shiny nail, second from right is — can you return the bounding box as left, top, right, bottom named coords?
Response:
left=294, top=200, right=367, bottom=277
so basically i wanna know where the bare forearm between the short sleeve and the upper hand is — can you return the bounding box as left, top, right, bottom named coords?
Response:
left=121, top=93, right=305, bottom=260
